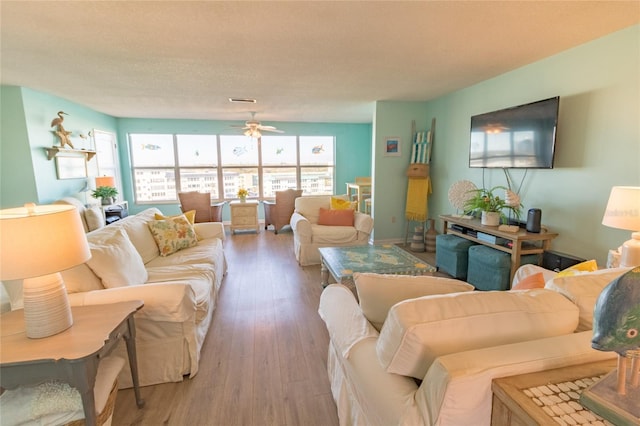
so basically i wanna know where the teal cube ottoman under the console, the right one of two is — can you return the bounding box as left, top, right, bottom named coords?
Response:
left=467, top=245, right=540, bottom=291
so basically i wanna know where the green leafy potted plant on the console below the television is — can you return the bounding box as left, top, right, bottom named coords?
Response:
left=464, top=186, right=520, bottom=226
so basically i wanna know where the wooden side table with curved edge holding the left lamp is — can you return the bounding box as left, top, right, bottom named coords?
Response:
left=0, top=300, right=144, bottom=426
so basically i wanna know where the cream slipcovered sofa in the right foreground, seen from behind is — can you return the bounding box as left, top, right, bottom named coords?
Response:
left=319, top=267, right=628, bottom=426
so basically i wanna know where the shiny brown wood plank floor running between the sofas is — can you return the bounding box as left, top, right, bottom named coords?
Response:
left=113, top=229, right=440, bottom=426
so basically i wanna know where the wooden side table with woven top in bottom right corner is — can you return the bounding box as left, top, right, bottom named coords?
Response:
left=491, top=359, right=616, bottom=426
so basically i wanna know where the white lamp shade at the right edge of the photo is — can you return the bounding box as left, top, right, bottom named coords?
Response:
left=602, top=186, right=640, bottom=231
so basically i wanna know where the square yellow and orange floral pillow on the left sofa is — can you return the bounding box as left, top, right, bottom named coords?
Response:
left=149, top=215, right=198, bottom=256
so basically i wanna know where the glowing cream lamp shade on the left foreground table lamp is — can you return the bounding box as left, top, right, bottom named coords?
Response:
left=0, top=205, right=91, bottom=280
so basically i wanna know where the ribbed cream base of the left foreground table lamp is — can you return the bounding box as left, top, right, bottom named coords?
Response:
left=22, top=272, right=73, bottom=339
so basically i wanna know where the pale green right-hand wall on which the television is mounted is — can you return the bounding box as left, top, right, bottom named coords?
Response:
left=374, top=25, right=640, bottom=265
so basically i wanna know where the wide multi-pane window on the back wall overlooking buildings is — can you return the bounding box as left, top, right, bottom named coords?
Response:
left=129, top=134, right=335, bottom=203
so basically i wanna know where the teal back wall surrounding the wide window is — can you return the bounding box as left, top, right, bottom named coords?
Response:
left=118, top=118, right=372, bottom=220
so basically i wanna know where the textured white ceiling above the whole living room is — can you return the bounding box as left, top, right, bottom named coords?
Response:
left=0, top=0, right=640, bottom=122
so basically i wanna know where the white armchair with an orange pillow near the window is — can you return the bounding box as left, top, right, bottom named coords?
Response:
left=290, top=195, right=373, bottom=266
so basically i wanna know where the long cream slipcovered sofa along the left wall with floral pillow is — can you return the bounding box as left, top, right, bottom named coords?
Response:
left=5, top=208, right=227, bottom=388
